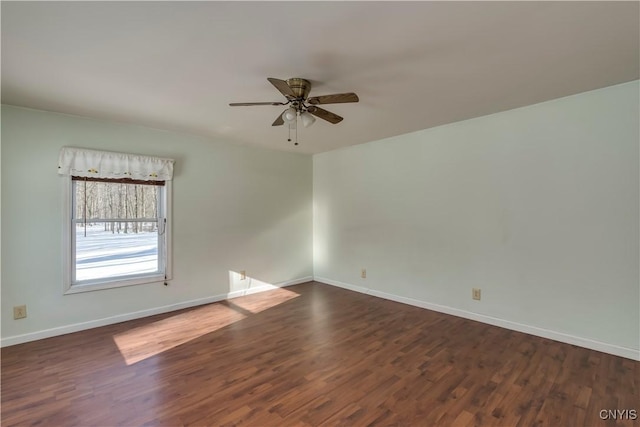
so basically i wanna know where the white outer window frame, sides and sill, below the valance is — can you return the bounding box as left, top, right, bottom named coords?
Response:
left=62, top=176, right=173, bottom=295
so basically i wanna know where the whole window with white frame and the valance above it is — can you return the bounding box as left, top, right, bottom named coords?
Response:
left=59, top=147, right=172, bottom=293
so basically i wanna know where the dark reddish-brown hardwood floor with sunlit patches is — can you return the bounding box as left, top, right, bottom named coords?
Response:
left=1, top=283, right=640, bottom=426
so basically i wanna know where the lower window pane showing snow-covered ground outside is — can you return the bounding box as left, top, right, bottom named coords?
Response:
left=75, top=221, right=160, bottom=282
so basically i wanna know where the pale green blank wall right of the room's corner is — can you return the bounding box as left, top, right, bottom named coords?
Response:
left=313, top=81, right=640, bottom=358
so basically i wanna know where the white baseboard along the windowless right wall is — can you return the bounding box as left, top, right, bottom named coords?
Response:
left=314, top=277, right=640, bottom=361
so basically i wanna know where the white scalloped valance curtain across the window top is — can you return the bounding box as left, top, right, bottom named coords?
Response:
left=58, top=147, right=174, bottom=181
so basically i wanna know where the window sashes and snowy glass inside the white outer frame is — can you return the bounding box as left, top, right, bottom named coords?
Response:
left=71, top=177, right=166, bottom=286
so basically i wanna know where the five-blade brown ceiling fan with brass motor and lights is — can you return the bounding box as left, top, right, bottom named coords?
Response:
left=229, top=77, right=359, bottom=127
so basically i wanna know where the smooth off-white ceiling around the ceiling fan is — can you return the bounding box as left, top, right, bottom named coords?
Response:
left=1, top=1, right=640, bottom=153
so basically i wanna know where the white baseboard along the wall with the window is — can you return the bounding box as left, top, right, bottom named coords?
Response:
left=0, top=276, right=313, bottom=347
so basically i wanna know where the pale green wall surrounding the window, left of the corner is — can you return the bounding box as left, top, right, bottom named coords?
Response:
left=2, top=106, right=313, bottom=339
